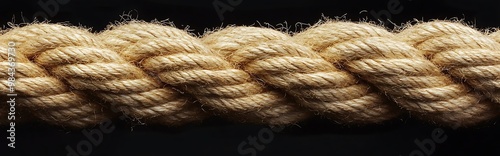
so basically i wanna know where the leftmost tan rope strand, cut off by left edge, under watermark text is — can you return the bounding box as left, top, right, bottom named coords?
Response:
left=0, top=32, right=106, bottom=127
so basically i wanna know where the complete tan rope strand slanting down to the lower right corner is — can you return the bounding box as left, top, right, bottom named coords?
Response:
left=295, top=22, right=498, bottom=126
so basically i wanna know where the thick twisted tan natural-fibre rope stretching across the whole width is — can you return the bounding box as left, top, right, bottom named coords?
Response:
left=0, top=21, right=500, bottom=128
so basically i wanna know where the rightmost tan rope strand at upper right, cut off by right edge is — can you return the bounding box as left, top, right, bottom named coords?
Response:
left=397, top=22, right=500, bottom=103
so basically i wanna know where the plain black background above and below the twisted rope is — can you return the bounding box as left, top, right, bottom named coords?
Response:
left=0, top=0, right=500, bottom=156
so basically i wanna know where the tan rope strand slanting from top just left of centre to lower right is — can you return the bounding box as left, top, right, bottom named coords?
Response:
left=202, top=27, right=399, bottom=123
